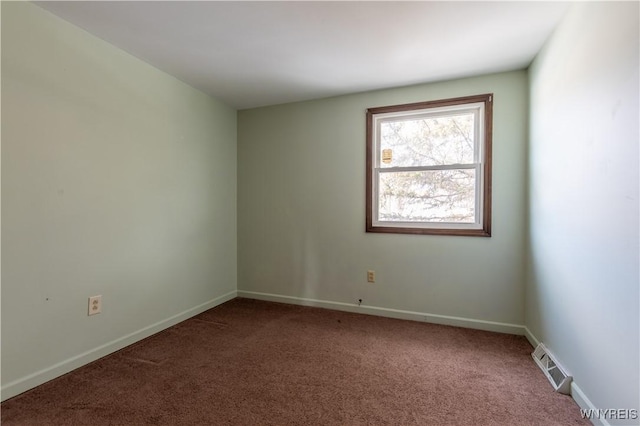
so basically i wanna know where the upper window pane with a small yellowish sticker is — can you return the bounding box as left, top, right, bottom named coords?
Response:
left=378, top=112, right=477, bottom=168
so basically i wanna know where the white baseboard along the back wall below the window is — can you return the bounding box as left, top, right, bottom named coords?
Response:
left=238, top=290, right=525, bottom=336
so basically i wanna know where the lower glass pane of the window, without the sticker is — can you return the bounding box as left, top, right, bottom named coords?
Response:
left=378, top=169, right=476, bottom=223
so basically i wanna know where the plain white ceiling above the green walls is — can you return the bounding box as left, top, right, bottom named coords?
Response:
left=37, top=1, right=568, bottom=109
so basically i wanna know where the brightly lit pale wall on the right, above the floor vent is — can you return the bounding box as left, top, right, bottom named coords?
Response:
left=526, top=2, right=640, bottom=418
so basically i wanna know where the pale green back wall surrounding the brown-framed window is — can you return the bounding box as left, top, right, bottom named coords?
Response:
left=238, top=71, right=528, bottom=324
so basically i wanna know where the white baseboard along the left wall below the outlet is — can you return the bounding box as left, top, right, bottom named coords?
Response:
left=0, top=290, right=236, bottom=401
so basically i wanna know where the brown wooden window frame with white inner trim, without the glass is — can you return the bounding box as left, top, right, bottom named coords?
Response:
left=366, top=93, right=493, bottom=237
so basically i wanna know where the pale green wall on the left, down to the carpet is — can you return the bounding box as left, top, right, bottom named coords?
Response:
left=2, top=2, right=237, bottom=398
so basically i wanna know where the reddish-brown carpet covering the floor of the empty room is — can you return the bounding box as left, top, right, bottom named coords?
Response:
left=1, top=298, right=590, bottom=426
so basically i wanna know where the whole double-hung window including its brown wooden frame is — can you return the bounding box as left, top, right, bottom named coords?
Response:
left=366, top=94, right=493, bottom=237
